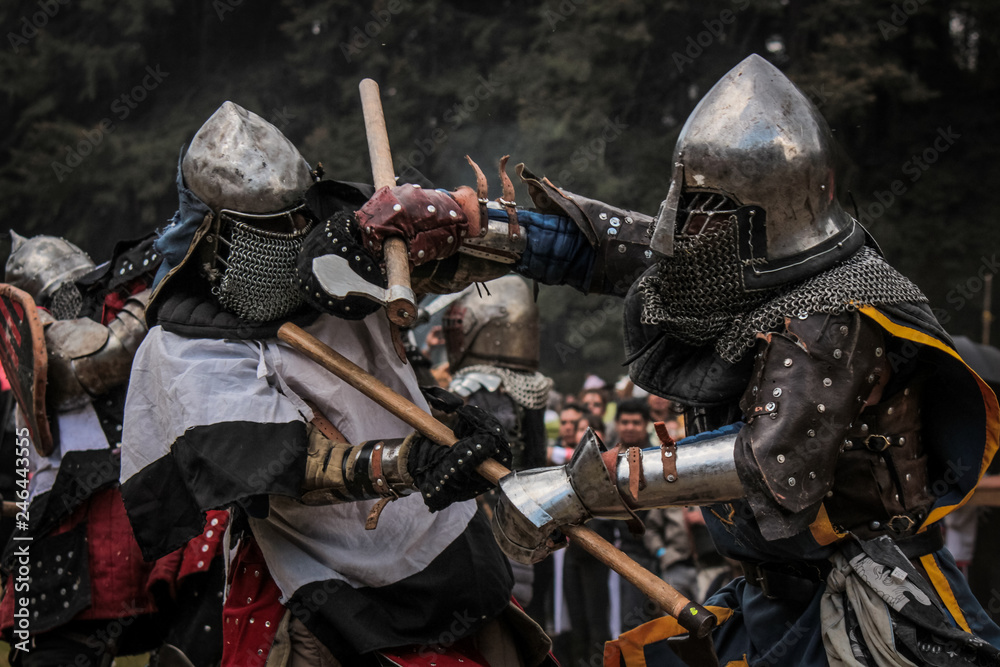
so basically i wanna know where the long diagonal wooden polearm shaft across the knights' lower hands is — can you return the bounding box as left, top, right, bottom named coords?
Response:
left=278, top=322, right=716, bottom=637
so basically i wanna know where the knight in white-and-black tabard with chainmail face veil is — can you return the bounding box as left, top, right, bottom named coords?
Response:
left=122, top=102, right=547, bottom=667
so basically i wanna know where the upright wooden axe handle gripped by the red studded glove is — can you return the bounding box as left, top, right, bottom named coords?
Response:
left=358, top=79, right=417, bottom=326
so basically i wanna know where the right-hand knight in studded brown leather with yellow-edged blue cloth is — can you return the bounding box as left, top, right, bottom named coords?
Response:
left=350, top=55, right=1000, bottom=665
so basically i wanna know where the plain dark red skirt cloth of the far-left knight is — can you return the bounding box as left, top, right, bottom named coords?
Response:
left=0, top=488, right=156, bottom=629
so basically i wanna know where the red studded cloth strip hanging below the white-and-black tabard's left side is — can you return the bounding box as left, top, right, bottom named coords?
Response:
left=222, top=537, right=285, bottom=667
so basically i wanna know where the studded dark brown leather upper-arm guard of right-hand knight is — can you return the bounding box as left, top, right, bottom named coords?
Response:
left=736, top=312, right=887, bottom=540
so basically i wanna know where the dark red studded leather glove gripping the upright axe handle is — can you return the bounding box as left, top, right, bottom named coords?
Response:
left=357, top=185, right=479, bottom=266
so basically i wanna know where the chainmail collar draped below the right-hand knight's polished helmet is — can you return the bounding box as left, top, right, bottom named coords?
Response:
left=638, top=246, right=927, bottom=363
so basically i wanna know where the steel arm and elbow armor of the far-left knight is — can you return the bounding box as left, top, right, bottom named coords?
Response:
left=45, top=289, right=150, bottom=411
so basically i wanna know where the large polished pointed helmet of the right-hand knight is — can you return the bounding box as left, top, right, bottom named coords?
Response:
left=651, top=55, right=865, bottom=288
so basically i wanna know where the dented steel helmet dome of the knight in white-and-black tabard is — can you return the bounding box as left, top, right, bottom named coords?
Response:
left=181, top=102, right=313, bottom=214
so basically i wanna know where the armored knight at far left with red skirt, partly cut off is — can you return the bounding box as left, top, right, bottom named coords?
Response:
left=0, top=232, right=226, bottom=666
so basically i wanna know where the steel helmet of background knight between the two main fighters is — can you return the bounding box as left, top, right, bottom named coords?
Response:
left=443, top=276, right=540, bottom=373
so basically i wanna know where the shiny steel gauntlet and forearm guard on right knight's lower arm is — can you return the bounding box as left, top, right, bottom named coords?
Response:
left=493, top=430, right=743, bottom=563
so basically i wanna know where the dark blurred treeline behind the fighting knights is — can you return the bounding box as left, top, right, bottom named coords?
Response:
left=0, top=0, right=1000, bottom=383
